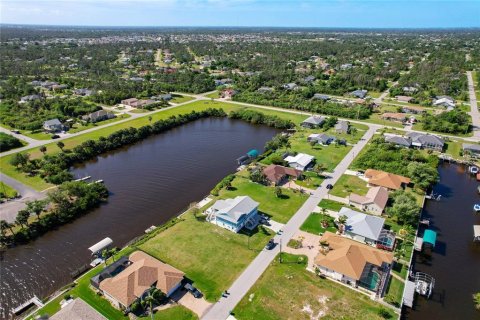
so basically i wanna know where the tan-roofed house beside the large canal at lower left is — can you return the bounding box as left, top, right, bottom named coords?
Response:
left=99, top=251, right=185, bottom=309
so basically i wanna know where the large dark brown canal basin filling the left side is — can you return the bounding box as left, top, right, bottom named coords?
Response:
left=0, top=118, right=278, bottom=319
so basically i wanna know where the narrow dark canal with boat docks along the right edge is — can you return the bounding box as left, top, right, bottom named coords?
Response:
left=404, top=164, right=480, bottom=320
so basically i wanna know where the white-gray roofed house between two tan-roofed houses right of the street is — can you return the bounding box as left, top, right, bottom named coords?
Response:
left=338, top=207, right=385, bottom=245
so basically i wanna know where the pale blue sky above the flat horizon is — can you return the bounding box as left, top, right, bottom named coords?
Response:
left=0, top=0, right=480, bottom=28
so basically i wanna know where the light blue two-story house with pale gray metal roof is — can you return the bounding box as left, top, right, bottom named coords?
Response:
left=205, top=196, right=259, bottom=232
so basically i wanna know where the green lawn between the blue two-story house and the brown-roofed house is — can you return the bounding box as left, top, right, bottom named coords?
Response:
left=219, top=175, right=307, bottom=223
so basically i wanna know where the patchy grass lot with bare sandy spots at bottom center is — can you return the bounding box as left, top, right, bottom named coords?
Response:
left=234, top=253, right=394, bottom=320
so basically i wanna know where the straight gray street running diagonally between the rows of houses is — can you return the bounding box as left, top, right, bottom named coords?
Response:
left=202, top=125, right=381, bottom=320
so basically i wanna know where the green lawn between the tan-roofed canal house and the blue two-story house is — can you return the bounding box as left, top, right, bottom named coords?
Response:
left=139, top=213, right=272, bottom=302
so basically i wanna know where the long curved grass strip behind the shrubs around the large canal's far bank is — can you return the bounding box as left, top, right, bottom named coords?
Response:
left=0, top=101, right=314, bottom=190
